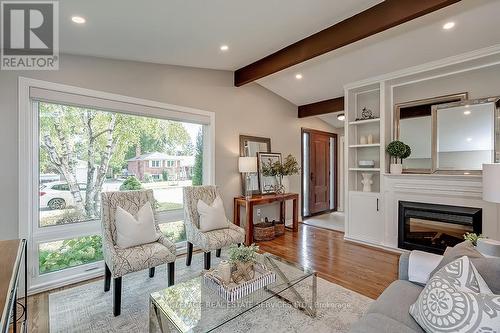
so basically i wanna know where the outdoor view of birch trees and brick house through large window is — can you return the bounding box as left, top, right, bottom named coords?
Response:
left=38, top=102, right=203, bottom=273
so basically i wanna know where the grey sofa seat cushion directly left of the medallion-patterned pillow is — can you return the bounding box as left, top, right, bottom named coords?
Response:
left=368, top=280, right=423, bottom=332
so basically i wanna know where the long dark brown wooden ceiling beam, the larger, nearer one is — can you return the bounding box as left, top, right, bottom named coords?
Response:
left=234, top=0, right=461, bottom=87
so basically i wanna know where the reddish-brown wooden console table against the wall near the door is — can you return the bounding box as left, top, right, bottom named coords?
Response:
left=233, top=193, right=299, bottom=246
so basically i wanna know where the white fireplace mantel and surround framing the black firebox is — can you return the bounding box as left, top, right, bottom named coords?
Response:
left=383, top=174, right=500, bottom=248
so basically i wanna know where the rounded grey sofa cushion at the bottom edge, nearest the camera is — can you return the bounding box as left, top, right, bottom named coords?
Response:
left=349, top=313, right=423, bottom=333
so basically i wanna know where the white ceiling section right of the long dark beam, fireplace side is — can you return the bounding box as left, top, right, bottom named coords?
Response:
left=258, top=0, right=500, bottom=105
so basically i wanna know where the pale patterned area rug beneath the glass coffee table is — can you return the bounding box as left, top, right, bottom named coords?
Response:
left=49, top=254, right=372, bottom=333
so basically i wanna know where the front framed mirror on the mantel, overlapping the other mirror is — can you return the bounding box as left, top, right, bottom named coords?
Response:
left=432, top=97, right=500, bottom=173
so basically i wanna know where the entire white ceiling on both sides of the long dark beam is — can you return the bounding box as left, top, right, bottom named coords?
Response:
left=59, top=0, right=500, bottom=105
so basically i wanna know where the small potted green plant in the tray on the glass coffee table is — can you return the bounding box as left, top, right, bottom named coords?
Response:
left=229, top=244, right=259, bottom=283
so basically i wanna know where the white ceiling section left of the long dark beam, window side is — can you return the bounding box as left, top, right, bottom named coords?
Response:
left=59, top=0, right=381, bottom=70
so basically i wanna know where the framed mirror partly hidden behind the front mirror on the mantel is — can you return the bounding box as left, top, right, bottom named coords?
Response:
left=394, top=93, right=468, bottom=173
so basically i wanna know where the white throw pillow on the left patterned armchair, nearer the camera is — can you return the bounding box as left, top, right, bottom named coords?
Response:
left=115, top=202, right=160, bottom=249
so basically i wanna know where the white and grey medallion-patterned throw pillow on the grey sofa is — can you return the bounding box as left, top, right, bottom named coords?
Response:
left=410, top=256, right=500, bottom=333
